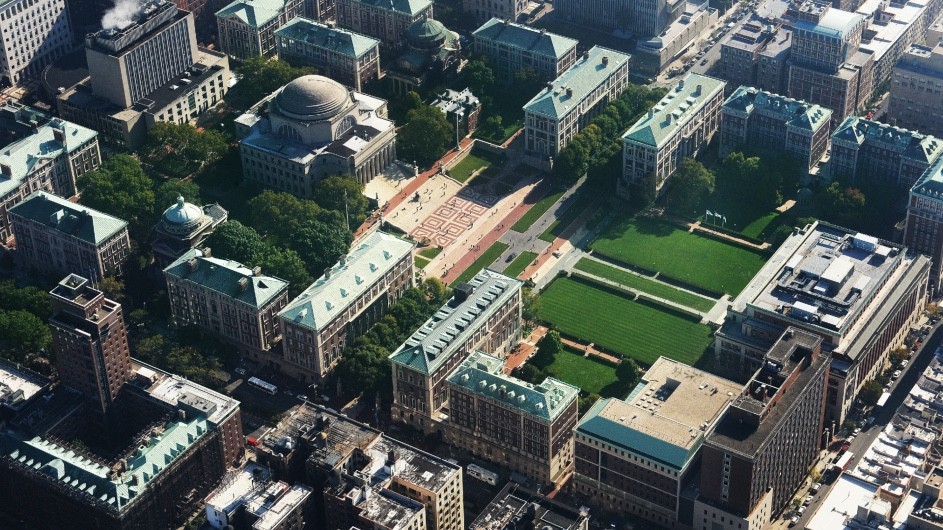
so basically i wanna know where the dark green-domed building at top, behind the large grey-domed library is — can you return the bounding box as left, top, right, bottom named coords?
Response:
left=387, top=18, right=462, bottom=95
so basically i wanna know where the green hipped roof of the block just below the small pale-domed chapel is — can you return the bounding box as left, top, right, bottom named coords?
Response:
left=164, top=249, right=288, bottom=309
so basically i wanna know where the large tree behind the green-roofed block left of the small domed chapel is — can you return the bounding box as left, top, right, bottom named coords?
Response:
left=78, top=155, right=154, bottom=234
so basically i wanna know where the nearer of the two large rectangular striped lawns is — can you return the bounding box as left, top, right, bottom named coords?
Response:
left=539, top=278, right=712, bottom=366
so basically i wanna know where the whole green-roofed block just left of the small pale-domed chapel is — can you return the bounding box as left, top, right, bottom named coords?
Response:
left=7, top=191, right=131, bottom=281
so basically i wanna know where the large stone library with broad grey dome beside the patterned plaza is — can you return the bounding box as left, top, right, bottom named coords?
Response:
left=236, top=75, right=396, bottom=198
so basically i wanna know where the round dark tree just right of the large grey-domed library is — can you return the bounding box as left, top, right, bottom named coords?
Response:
left=396, top=105, right=455, bottom=167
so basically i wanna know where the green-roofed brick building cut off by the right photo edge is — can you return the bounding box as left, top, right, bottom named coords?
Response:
left=904, top=158, right=943, bottom=290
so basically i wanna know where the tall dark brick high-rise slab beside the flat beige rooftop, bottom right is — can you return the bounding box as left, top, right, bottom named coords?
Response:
left=692, top=327, right=830, bottom=530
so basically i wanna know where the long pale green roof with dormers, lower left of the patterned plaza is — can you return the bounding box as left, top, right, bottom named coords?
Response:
left=278, top=231, right=413, bottom=331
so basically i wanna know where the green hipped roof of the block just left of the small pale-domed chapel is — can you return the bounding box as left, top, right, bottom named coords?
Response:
left=10, top=191, right=128, bottom=246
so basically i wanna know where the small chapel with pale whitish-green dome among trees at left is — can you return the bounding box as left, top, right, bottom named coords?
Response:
left=151, top=197, right=229, bottom=269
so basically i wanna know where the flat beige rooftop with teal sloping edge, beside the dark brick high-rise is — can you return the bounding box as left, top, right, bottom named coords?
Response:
left=577, top=357, right=743, bottom=470
